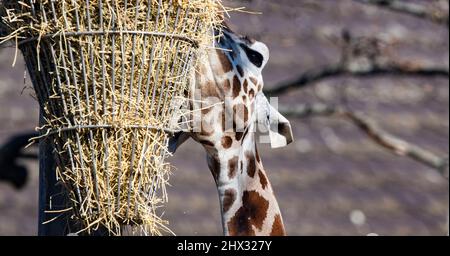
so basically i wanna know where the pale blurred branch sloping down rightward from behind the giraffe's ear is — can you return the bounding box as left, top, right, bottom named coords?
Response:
left=279, top=103, right=449, bottom=179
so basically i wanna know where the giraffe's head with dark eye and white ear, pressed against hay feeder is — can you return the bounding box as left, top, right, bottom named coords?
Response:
left=170, top=27, right=293, bottom=154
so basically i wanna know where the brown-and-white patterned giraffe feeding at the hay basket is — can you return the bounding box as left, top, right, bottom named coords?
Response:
left=169, top=26, right=293, bottom=236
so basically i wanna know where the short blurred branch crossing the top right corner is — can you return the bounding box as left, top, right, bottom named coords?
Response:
left=355, top=0, right=449, bottom=27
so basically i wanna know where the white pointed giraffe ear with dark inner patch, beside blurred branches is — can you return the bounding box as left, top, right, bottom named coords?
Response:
left=255, top=93, right=294, bottom=148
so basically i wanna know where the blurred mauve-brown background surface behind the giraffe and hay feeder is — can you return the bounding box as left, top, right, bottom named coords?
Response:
left=0, top=0, right=449, bottom=235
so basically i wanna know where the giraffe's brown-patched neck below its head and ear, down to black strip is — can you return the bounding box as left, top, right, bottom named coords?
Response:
left=204, top=128, right=285, bottom=236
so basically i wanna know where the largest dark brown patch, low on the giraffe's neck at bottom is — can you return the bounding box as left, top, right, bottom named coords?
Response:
left=227, top=191, right=269, bottom=236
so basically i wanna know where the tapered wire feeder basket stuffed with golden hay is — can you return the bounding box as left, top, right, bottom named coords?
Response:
left=0, top=0, right=221, bottom=235
